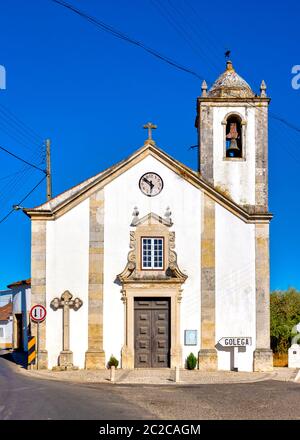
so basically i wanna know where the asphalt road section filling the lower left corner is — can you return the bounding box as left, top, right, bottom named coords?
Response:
left=0, top=356, right=153, bottom=420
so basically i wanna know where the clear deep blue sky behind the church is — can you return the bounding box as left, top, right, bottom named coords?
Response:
left=0, top=0, right=300, bottom=289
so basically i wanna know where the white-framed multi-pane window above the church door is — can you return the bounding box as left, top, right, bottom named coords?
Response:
left=142, top=237, right=164, bottom=270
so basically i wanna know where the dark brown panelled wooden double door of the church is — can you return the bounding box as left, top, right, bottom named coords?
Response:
left=134, top=298, right=170, bottom=368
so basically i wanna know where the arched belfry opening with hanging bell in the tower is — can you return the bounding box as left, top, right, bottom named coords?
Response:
left=226, top=115, right=243, bottom=158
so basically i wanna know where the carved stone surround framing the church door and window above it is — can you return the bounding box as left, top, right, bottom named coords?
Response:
left=117, top=208, right=187, bottom=368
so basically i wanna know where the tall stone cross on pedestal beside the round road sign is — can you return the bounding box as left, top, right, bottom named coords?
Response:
left=50, top=290, right=82, bottom=370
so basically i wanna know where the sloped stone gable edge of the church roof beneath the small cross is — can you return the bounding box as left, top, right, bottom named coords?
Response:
left=23, top=141, right=272, bottom=223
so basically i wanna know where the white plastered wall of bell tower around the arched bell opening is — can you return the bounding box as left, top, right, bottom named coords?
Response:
left=213, top=107, right=255, bottom=205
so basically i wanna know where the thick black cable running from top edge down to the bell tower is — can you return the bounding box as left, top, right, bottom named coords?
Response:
left=51, top=0, right=204, bottom=79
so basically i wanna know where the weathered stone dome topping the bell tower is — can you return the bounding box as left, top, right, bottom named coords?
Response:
left=207, top=61, right=255, bottom=98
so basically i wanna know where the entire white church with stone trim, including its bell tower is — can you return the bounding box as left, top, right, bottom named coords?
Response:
left=25, top=62, right=273, bottom=371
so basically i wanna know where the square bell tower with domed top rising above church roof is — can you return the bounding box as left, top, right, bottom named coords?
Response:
left=196, top=61, right=270, bottom=213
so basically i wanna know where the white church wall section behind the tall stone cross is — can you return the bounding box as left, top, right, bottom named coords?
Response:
left=46, top=199, right=89, bottom=368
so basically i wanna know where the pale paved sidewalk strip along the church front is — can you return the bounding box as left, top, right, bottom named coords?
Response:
left=18, top=368, right=298, bottom=385
